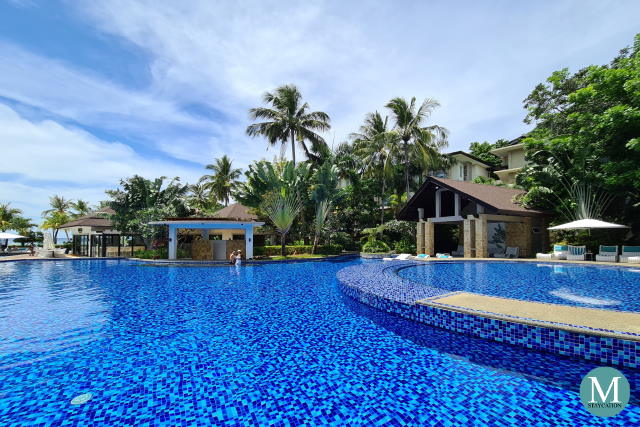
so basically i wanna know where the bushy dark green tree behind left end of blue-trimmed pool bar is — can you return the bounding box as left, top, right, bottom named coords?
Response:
left=106, top=175, right=189, bottom=248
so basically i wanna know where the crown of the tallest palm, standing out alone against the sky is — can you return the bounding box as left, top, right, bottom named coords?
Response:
left=247, top=84, right=331, bottom=166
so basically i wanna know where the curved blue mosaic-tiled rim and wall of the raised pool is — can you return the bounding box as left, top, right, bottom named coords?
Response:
left=338, top=262, right=640, bottom=368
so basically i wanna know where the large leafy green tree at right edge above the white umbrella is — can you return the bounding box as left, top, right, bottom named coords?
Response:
left=517, top=34, right=640, bottom=240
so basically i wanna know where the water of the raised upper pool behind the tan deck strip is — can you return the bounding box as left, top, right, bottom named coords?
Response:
left=398, top=261, right=640, bottom=312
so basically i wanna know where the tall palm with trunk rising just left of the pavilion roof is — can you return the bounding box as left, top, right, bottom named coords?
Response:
left=386, top=97, right=447, bottom=197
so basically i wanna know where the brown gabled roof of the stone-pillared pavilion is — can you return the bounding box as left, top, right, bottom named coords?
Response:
left=398, top=176, right=545, bottom=218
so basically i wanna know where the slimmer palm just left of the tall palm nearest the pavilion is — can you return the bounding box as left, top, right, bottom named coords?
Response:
left=351, top=111, right=398, bottom=225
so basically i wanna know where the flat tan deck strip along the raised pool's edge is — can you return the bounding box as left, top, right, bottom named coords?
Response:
left=416, top=292, right=640, bottom=340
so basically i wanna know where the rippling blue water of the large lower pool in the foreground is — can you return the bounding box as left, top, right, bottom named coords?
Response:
left=0, top=260, right=640, bottom=426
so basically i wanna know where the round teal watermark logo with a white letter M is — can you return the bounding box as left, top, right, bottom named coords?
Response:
left=580, top=367, right=631, bottom=417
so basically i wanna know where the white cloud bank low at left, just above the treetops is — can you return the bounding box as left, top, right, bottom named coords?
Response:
left=0, top=104, right=200, bottom=221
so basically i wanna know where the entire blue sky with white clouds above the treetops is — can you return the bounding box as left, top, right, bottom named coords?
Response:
left=0, top=0, right=640, bottom=222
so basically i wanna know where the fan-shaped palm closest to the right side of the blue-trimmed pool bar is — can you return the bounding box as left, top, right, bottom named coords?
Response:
left=260, top=187, right=304, bottom=256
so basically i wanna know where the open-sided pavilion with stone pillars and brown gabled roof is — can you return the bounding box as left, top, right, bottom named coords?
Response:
left=397, top=177, right=549, bottom=258
